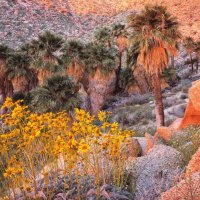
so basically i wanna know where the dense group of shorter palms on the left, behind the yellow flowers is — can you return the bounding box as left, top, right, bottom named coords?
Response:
left=0, top=31, right=121, bottom=112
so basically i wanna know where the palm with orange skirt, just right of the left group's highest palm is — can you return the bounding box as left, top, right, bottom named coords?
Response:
left=62, top=40, right=85, bottom=83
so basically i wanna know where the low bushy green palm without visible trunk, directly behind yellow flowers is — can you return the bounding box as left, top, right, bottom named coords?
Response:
left=31, top=75, right=80, bottom=113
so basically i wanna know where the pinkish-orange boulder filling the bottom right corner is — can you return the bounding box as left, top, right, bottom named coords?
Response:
left=161, top=172, right=200, bottom=200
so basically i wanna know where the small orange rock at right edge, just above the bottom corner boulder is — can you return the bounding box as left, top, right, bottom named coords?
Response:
left=186, top=148, right=200, bottom=177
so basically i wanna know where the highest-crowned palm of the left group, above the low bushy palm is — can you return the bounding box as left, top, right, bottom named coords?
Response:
left=31, top=31, right=64, bottom=86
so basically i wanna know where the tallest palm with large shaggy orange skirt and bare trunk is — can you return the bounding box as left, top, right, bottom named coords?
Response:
left=129, top=5, right=179, bottom=127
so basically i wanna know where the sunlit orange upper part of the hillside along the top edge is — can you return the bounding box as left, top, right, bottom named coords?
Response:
left=17, top=0, right=200, bottom=40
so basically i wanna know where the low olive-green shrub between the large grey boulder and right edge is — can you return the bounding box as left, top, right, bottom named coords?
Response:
left=169, top=126, right=200, bottom=164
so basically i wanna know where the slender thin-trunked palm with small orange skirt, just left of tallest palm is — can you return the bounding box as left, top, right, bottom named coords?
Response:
left=112, top=24, right=128, bottom=90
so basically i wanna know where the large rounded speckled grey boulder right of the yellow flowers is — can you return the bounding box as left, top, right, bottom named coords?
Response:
left=129, top=144, right=184, bottom=200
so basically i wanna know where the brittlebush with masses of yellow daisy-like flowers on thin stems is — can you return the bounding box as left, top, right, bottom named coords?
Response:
left=0, top=98, right=133, bottom=198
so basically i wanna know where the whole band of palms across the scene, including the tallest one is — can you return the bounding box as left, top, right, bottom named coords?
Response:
left=0, top=5, right=200, bottom=126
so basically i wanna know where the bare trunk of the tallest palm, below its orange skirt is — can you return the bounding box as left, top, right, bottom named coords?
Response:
left=152, top=74, right=164, bottom=127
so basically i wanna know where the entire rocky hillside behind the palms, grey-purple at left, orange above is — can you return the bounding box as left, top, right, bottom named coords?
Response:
left=0, top=0, right=200, bottom=46
